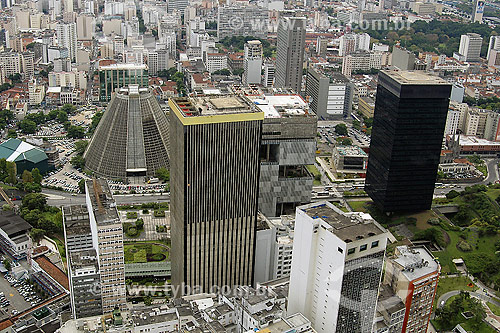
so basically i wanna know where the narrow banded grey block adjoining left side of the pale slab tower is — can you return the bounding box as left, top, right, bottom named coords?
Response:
left=63, top=205, right=102, bottom=319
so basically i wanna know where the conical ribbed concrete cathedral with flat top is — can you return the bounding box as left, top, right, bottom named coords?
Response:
left=84, top=85, right=169, bottom=179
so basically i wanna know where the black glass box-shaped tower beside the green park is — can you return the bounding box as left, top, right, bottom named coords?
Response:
left=365, top=71, right=451, bottom=212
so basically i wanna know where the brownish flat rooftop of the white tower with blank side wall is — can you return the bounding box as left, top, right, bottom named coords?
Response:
left=299, top=202, right=386, bottom=243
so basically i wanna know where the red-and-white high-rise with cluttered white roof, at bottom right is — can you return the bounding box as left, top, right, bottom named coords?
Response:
left=384, top=246, right=441, bottom=333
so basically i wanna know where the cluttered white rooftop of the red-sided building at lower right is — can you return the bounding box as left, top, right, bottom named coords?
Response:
left=393, top=246, right=439, bottom=281
